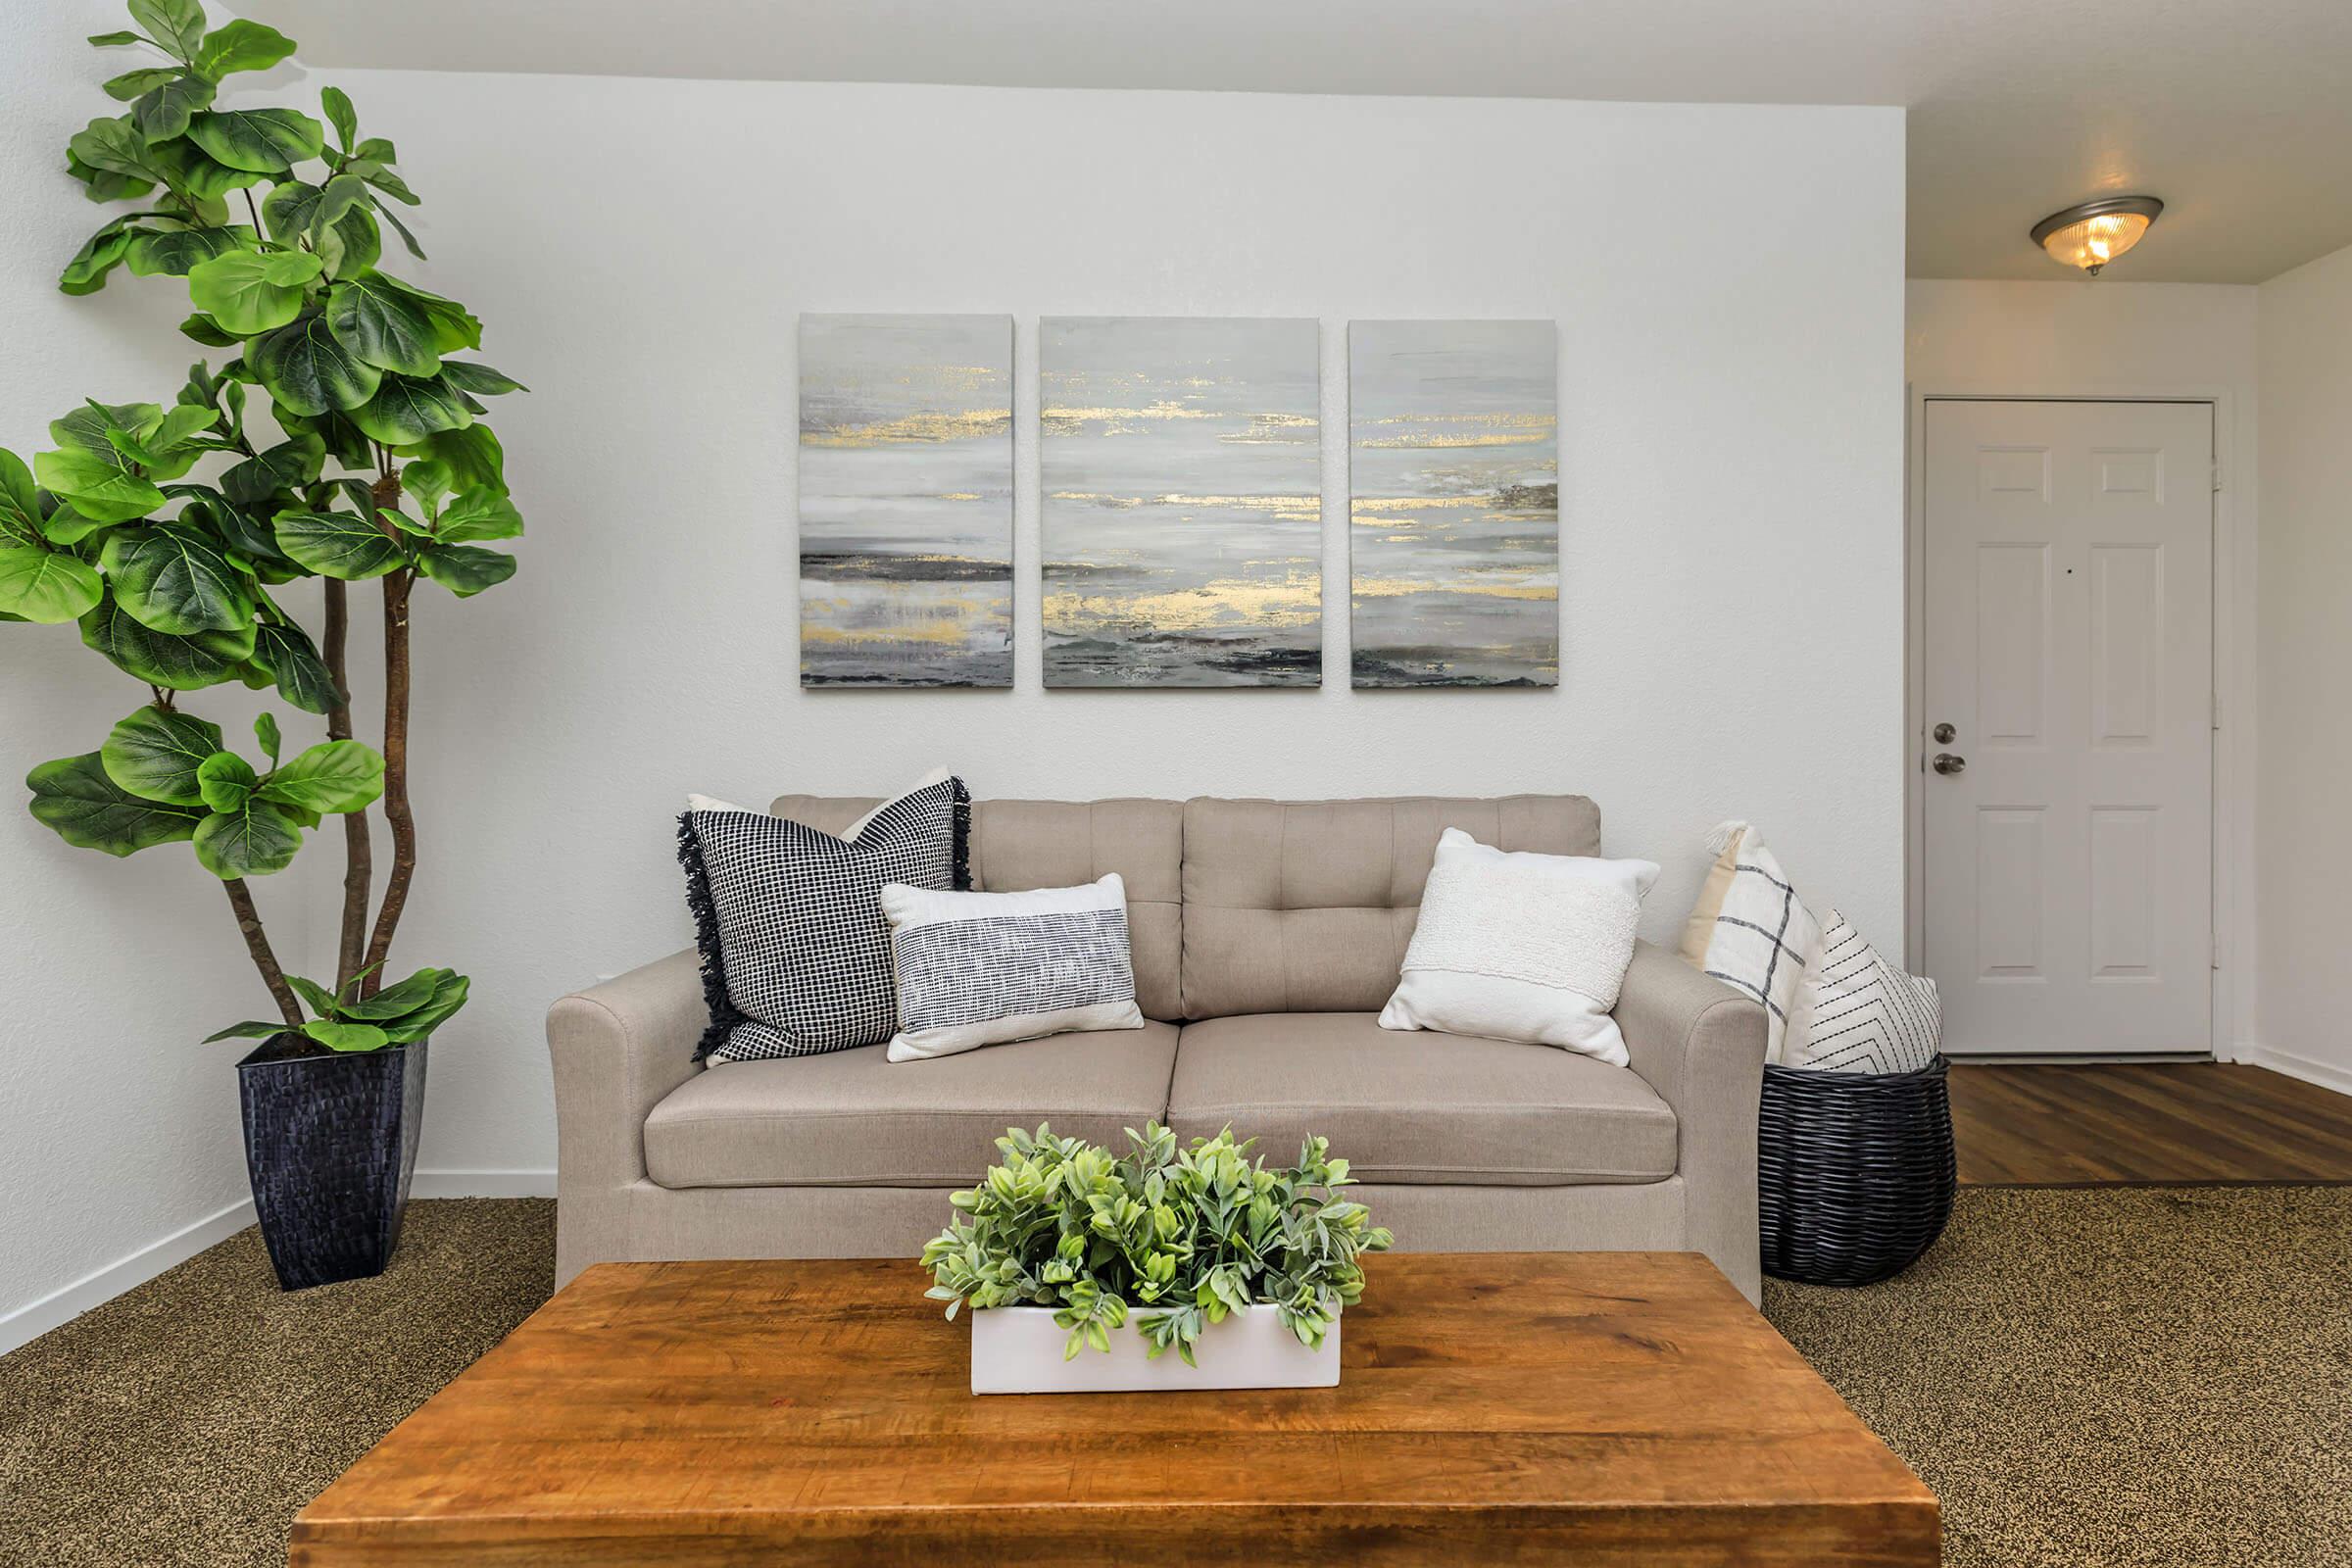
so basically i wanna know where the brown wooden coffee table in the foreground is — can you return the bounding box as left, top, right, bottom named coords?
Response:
left=292, top=1253, right=1938, bottom=1568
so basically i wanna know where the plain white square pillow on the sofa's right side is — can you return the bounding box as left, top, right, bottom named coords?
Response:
left=1381, top=827, right=1658, bottom=1067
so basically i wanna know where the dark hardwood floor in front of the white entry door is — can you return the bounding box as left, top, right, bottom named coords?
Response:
left=1952, top=1062, right=2352, bottom=1187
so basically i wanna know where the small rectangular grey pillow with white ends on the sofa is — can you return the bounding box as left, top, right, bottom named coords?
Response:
left=882, top=872, right=1143, bottom=1062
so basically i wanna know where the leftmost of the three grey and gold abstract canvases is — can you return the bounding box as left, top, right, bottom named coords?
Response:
left=800, top=315, right=1013, bottom=686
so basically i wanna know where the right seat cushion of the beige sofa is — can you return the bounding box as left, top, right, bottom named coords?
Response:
left=1166, top=1013, right=1675, bottom=1187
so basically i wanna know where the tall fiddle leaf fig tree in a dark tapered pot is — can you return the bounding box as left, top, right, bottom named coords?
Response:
left=0, top=0, right=522, bottom=1289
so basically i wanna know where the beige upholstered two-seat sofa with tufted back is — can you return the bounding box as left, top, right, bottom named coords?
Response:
left=548, top=795, right=1764, bottom=1300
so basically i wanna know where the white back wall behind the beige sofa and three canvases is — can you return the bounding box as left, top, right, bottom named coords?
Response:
left=0, top=61, right=1903, bottom=1325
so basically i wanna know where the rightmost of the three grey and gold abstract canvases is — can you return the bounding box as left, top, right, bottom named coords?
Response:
left=1348, top=322, right=1559, bottom=686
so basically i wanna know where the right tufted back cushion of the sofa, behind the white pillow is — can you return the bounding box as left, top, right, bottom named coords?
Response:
left=1185, top=795, right=1601, bottom=1018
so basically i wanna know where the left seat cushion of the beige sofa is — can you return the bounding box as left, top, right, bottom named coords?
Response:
left=645, top=1022, right=1176, bottom=1187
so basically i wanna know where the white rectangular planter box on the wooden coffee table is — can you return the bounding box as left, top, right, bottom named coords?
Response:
left=971, top=1307, right=1339, bottom=1394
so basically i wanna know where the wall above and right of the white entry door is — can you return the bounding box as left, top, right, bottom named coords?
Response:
left=1905, top=279, right=2270, bottom=1055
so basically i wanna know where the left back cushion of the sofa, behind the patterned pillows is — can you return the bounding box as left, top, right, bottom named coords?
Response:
left=769, top=795, right=1185, bottom=1020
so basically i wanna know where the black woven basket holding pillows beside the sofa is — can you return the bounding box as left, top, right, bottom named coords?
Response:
left=1757, top=1055, right=1957, bottom=1286
